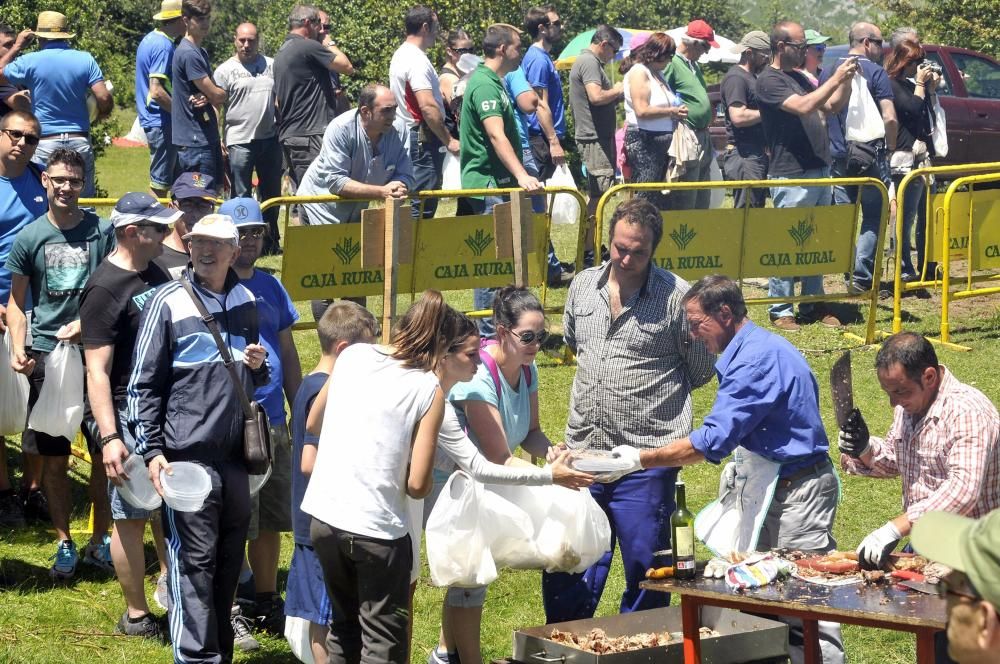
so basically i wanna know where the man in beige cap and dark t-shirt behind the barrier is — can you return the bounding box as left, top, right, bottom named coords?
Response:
left=719, top=30, right=771, bottom=208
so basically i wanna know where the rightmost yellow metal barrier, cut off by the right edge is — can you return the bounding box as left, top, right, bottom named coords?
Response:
left=940, top=173, right=1000, bottom=343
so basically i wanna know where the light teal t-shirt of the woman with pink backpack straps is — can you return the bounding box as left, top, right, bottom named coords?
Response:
left=448, top=362, right=538, bottom=452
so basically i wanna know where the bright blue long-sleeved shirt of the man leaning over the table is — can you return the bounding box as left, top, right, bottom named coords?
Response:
left=690, top=320, right=830, bottom=477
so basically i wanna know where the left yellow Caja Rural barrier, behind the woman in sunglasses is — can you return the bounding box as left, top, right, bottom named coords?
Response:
left=261, top=187, right=587, bottom=330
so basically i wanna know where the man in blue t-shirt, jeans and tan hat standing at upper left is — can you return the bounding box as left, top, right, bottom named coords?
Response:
left=135, top=0, right=184, bottom=198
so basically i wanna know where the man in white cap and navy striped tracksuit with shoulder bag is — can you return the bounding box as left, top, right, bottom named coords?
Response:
left=127, top=214, right=268, bottom=662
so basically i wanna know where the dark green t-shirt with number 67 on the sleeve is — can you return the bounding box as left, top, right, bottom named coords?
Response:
left=458, top=65, right=521, bottom=189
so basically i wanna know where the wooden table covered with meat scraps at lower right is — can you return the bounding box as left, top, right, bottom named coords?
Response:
left=640, top=577, right=947, bottom=664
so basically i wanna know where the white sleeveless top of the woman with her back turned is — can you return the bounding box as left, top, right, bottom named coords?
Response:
left=302, top=344, right=438, bottom=540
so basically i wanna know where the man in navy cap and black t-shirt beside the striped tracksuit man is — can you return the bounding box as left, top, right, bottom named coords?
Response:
left=80, top=192, right=182, bottom=639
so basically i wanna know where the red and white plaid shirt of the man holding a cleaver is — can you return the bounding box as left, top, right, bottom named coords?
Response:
left=840, top=367, right=1000, bottom=522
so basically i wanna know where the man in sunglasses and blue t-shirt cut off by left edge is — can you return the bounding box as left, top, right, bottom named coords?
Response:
left=0, top=111, right=49, bottom=527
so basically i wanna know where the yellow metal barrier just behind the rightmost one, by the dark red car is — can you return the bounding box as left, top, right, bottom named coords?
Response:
left=892, top=162, right=1000, bottom=334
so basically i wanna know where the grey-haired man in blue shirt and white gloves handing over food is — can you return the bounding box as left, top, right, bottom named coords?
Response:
left=613, top=275, right=844, bottom=664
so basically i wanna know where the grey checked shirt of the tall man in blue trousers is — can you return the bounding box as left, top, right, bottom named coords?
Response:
left=563, top=263, right=715, bottom=451
